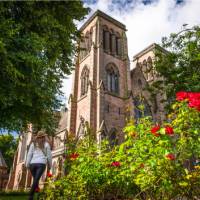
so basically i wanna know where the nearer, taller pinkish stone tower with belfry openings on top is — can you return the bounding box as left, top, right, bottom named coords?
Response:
left=68, top=10, right=131, bottom=143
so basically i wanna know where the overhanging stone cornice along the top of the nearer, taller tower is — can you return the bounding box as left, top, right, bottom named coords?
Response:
left=79, top=10, right=126, bottom=31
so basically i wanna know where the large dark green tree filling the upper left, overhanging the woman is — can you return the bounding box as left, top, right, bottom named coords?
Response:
left=0, top=0, right=88, bottom=132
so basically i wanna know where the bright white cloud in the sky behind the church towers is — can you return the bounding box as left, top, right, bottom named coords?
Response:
left=61, top=0, right=200, bottom=103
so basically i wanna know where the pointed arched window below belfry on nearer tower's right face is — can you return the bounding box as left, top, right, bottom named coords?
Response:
left=106, top=64, right=119, bottom=94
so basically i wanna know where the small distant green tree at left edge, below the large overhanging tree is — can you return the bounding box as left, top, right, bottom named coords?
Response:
left=0, top=133, right=18, bottom=169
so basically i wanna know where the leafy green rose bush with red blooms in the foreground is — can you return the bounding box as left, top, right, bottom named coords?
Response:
left=41, top=92, right=200, bottom=200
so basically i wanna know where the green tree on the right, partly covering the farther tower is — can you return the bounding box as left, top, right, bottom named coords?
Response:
left=151, top=26, right=200, bottom=101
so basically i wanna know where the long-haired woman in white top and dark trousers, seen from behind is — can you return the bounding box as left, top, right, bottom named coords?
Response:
left=26, top=131, right=52, bottom=200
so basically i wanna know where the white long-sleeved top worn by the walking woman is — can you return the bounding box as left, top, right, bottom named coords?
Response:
left=26, top=142, right=52, bottom=169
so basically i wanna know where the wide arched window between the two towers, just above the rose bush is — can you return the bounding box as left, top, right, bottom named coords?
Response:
left=133, top=96, right=152, bottom=120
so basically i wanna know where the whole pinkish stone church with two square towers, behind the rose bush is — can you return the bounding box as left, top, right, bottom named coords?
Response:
left=7, top=10, right=165, bottom=190
